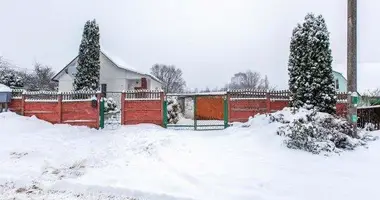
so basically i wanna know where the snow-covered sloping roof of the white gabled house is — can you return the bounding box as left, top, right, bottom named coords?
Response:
left=52, top=49, right=162, bottom=84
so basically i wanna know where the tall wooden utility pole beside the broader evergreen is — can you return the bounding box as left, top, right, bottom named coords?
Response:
left=347, top=0, right=358, bottom=136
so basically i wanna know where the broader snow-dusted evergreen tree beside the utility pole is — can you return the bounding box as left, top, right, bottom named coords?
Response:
left=288, top=14, right=336, bottom=113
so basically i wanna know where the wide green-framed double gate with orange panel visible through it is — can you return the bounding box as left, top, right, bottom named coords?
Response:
left=163, top=94, right=229, bottom=130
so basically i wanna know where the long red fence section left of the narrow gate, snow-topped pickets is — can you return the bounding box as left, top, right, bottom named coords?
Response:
left=10, top=91, right=100, bottom=128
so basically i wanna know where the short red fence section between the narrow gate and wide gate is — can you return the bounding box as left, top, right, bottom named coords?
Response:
left=121, top=90, right=164, bottom=125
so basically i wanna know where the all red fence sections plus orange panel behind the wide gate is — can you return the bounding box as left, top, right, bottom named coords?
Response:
left=9, top=90, right=347, bottom=128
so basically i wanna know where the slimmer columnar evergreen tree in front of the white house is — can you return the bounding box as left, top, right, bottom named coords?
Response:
left=74, top=19, right=100, bottom=90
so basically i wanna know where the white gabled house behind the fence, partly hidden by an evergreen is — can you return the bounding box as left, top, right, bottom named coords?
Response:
left=52, top=51, right=162, bottom=92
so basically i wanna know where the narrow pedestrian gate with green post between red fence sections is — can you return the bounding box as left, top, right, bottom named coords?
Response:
left=100, top=92, right=122, bottom=129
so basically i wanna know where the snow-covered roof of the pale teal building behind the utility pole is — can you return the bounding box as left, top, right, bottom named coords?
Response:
left=333, top=63, right=380, bottom=93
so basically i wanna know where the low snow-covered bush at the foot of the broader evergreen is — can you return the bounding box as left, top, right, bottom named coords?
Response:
left=269, top=109, right=377, bottom=154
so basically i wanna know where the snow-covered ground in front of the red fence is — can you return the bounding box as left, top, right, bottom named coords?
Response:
left=0, top=113, right=380, bottom=200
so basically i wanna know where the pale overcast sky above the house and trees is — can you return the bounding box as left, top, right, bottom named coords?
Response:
left=0, top=0, right=380, bottom=88
